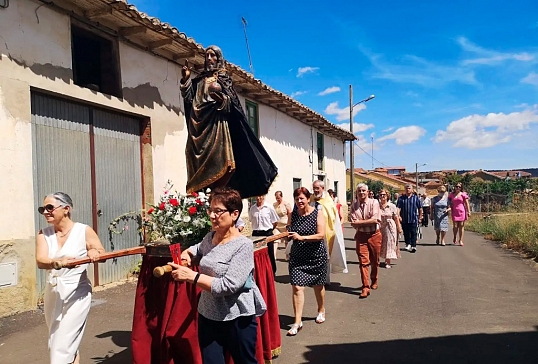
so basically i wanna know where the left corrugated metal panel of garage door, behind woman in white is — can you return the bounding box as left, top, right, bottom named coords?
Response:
left=31, top=93, right=92, bottom=295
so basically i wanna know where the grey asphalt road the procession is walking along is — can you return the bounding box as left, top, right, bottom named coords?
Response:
left=0, top=223, right=538, bottom=364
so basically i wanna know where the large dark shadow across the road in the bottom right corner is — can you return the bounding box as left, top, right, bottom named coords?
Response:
left=303, top=331, right=538, bottom=364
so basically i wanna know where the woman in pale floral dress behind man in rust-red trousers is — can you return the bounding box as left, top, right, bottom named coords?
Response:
left=379, top=190, right=402, bottom=269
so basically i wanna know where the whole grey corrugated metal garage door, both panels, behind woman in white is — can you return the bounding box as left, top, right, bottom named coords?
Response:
left=32, top=93, right=142, bottom=293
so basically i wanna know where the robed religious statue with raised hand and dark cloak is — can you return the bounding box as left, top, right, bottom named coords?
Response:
left=180, top=46, right=277, bottom=198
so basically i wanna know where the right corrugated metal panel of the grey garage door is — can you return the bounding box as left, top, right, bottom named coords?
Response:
left=93, top=110, right=142, bottom=284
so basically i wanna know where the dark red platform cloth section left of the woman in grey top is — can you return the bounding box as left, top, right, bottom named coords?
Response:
left=131, top=256, right=202, bottom=364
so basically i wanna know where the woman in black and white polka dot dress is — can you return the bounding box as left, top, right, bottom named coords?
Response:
left=288, top=187, right=329, bottom=336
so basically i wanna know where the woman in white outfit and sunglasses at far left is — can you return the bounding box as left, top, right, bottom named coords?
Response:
left=36, top=192, right=105, bottom=364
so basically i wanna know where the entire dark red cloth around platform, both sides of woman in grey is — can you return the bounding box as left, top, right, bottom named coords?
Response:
left=131, top=248, right=281, bottom=364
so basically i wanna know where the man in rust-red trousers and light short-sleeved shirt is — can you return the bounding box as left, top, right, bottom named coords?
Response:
left=351, top=183, right=382, bottom=298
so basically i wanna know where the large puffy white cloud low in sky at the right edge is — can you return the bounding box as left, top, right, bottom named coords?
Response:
left=433, top=109, right=538, bottom=149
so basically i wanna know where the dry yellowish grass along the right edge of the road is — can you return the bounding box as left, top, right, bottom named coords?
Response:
left=465, top=211, right=538, bottom=258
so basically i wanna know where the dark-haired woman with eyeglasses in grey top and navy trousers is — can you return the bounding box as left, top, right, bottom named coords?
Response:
left=169, top=187, right=267, bottom=364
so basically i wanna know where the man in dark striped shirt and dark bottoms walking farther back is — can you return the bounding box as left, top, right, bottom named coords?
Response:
left=396, top=183, right=422, bottom=253
